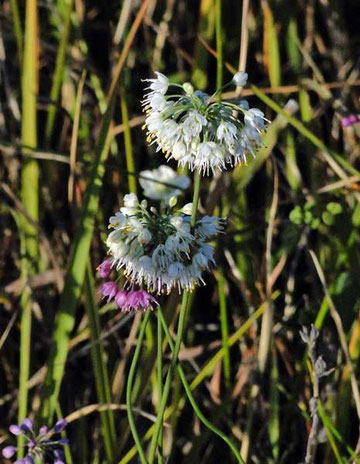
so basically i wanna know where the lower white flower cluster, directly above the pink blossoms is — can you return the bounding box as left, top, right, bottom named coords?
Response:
left=106, top=194, right=223, bottom=294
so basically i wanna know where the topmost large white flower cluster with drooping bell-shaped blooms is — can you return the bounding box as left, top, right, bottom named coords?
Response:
left=142, top=72, right=266, bottom=175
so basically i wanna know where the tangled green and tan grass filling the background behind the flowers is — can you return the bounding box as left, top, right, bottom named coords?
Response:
left=0, top=0, right=360, bottom=464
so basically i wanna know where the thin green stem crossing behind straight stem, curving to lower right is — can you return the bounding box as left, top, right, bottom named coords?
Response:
left=157, top=306, right=244, bottom=464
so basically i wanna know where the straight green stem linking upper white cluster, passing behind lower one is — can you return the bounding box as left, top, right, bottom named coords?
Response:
left=149, top=171, right=201, bottom=464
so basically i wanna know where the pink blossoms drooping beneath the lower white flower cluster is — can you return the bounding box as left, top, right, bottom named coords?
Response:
left=98, top=261, right=159, bottom=311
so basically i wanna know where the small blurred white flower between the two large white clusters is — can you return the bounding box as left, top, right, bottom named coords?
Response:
left=139, top=164, right=190, bottom=202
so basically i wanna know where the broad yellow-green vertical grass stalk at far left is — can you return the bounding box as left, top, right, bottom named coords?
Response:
left=18, top=0, right=39, bottom=457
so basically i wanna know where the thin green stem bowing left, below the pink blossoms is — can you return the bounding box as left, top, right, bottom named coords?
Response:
left=126, top=310, right=151, bottom=464
